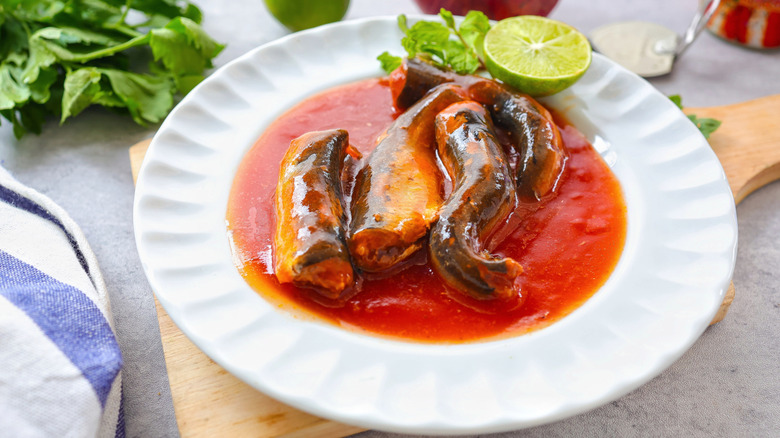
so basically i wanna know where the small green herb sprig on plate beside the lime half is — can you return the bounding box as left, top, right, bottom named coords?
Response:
left=377, top=9, right=490, bottom=74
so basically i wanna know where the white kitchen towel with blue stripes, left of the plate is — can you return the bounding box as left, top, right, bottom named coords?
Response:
left=0, top=167, right=125, bottom=437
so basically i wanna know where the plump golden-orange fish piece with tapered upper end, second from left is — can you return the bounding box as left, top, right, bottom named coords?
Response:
left=347, top=85, right=464, bottom=272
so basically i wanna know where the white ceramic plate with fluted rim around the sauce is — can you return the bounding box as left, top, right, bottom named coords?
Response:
left=134, top=17, right=737, bottom=434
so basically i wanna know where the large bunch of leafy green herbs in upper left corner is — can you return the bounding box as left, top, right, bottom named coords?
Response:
left=0, top=0, right=223, bottom=138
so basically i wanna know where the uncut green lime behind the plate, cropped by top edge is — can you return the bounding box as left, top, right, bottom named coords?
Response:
left=265, top=0, right=349, bottom=32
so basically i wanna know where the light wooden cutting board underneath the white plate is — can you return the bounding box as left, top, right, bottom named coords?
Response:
left=130, top=94, right=780, bottom=438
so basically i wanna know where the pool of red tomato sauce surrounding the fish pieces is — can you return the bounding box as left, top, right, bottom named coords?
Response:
left=227, top=79, right=626, bottom=343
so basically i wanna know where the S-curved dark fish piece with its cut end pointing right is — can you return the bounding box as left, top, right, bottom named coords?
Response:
left=429, top=101, right=522, bottom=300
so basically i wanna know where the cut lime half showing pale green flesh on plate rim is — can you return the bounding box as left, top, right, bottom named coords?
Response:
left=485, top=15, right=591, bottom=96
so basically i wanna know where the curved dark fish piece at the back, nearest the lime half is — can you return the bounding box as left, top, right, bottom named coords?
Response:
left=390, top=58, right=567, bottom=199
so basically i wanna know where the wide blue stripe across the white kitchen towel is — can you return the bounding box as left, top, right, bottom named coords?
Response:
left=0, top=250, right=122, bottom=407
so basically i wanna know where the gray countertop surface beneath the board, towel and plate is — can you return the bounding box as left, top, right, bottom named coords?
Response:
left=0, top=0, right=780, bottom=438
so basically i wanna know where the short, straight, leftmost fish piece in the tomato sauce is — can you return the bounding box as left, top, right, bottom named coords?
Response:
left=274, top=129, right=354, bottom=299
